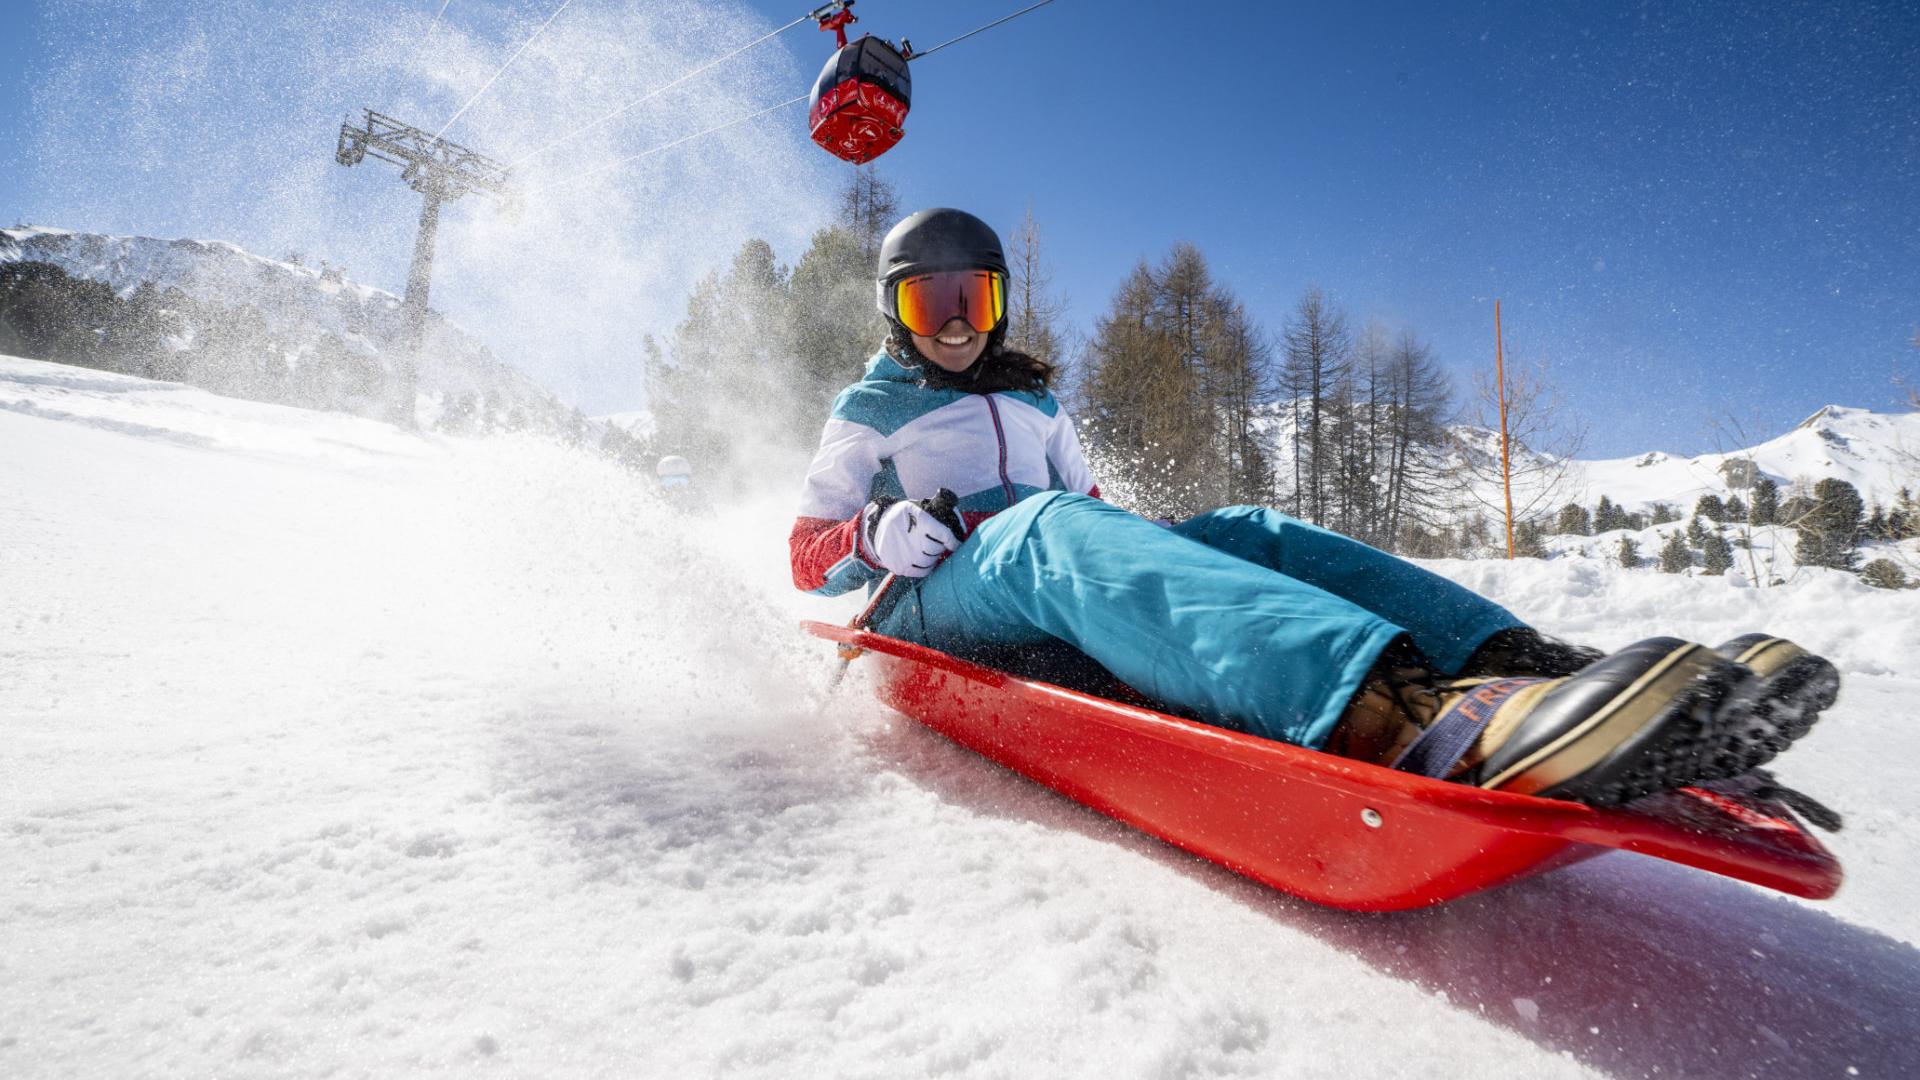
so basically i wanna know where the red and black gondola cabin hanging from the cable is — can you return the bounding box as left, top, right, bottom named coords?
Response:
left=806, top=0, right=914, bottom=165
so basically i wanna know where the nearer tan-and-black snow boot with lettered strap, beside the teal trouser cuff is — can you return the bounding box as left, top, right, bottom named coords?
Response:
left=1327, top=638, right=1759, bottom=805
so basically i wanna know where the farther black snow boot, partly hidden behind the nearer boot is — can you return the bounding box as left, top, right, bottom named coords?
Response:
left=1707, top=634, right=1839, bottom=778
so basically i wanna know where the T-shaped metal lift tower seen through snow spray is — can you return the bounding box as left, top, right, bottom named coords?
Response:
left=334, top=110, right=513, bottom=425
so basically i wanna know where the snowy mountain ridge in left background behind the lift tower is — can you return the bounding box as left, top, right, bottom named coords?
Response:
left=0, top=225, right=572, bottom=430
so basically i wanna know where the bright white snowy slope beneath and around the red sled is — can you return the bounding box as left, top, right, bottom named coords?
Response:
left=0, top=359, right=1920, bottom=1080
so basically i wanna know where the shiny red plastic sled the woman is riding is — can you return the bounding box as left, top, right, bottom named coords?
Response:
left=803, top=623, right=1841, bottom=911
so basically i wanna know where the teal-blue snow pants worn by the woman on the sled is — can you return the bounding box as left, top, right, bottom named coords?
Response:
left=874, top=492, right=1521, bottom=749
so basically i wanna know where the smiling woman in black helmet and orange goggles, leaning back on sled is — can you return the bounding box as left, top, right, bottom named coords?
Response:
left=791, top=209, right=1837, bottom=805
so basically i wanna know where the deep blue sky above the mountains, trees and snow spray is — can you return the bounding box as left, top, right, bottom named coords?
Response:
left=0, top=0, right=1920, bottom=455
